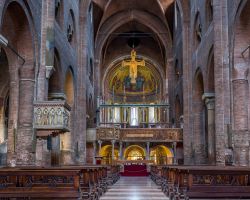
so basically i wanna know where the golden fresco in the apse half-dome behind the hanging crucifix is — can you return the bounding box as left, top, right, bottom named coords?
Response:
left=109, top=64, right=158, bottom=96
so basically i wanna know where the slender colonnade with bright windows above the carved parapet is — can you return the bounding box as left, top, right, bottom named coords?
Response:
left=98, top=103, right=169, bottom=128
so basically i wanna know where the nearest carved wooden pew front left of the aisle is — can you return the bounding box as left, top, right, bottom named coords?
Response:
left=0, top=168, right=81, bottom=200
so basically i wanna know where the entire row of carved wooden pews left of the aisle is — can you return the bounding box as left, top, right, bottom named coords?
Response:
left=0, top=165, right=120, bottom=200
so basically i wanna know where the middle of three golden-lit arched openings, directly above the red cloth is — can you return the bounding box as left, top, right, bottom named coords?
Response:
left=124, top=145, right=146, bottom=160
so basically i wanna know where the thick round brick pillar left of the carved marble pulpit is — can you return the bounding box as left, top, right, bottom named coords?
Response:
left=16, top=61, right=36, bottom=165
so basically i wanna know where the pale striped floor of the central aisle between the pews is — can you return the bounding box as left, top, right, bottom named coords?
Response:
left=101, top=177, right=168, bottom=200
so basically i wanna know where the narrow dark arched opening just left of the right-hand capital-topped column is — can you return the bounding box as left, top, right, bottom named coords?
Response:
left=193, top=68, right=207, bottom=164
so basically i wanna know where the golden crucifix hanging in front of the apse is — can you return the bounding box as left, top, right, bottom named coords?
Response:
left=122, top=49, right=145, bottom=84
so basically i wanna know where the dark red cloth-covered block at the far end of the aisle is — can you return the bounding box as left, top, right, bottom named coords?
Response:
left=121, top=165, right=149, bottom=176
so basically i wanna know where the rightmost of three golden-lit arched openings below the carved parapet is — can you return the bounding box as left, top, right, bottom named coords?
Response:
left=150, top=145, right=174, bottom=165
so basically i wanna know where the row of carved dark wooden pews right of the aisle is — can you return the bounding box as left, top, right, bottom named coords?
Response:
left=151, top=165, right=250, bottom=200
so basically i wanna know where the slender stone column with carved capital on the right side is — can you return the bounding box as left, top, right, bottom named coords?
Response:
left=203, top=93, right=216, bottom=165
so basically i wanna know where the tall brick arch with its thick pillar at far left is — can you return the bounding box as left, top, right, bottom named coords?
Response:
left=1, top=1, right=37, bottom=165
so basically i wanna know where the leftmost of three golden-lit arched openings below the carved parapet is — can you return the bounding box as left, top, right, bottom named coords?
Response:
left=100, top=145, right=119, bottom=165
